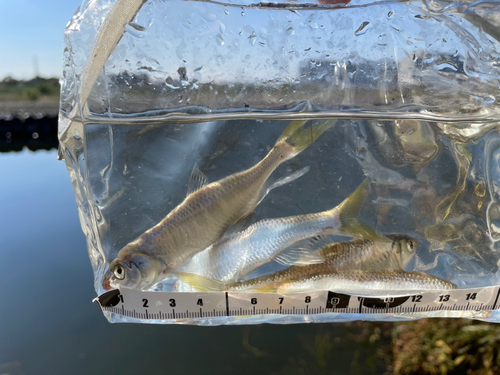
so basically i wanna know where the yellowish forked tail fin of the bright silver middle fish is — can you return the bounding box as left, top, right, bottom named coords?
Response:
left=338, top=178, right=390, bottom=242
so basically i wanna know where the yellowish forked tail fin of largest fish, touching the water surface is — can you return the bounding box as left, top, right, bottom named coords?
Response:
left=276, top=120, right=336, bottom=159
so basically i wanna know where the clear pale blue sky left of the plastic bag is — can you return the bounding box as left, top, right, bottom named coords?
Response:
left=0, top=0, right=82, bottom=80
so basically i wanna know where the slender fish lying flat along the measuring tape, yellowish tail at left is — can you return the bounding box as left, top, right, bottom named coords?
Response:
left=179, top=271, right=457, bottom=297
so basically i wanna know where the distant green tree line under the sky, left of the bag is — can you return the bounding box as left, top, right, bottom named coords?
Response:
left=0, top=76, right=60, bottom=101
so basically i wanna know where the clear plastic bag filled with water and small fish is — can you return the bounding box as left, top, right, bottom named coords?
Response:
left=59, top=0, right=500, bottom=324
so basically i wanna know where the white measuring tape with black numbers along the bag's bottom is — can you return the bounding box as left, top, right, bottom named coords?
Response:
left=94, top=286, right=500, bottom=321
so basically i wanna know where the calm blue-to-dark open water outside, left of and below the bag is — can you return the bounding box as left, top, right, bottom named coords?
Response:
left=0, top=150, right=389, bottom=375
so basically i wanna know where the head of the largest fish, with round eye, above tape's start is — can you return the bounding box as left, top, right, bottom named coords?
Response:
left=102, top=252, right=161, bottom=290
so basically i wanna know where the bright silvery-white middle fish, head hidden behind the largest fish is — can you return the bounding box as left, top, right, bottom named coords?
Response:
left=179, top=180, right=386, bottom=282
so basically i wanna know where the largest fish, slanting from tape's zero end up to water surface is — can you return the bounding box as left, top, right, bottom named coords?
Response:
left=102, top=120, right=334, bottom=290
